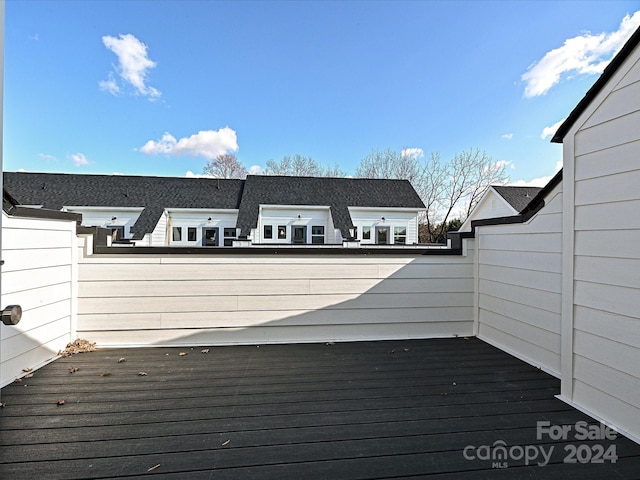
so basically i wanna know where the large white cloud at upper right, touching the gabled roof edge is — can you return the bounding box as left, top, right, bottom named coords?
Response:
left=521, top=10, right=640, bottom=98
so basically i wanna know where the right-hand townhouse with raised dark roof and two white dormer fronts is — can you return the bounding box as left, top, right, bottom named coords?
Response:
left=238, top=176, right=424, bottom=245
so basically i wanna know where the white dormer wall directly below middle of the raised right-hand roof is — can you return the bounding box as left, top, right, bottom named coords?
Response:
left=252, top=205, right=340, bottom=244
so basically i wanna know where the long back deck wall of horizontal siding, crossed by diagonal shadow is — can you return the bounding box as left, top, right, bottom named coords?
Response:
left=78, top=241, right=473, bottom=345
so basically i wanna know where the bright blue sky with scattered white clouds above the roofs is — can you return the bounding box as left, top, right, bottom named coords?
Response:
left=4, top=0, right=640, bottom=184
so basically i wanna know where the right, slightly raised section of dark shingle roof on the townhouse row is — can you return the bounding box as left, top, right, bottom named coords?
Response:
left=237, top=175, right=424, bottom=237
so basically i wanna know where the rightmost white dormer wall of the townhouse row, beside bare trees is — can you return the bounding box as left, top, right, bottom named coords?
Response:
left=349, top=207, right=418, bottom=245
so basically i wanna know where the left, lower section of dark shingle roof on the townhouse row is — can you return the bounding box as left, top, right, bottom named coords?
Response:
left=4, top=172, right=244, bottom=239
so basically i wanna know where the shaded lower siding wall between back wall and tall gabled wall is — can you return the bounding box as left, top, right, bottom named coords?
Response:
left=476, top=185, right=562, bottom=375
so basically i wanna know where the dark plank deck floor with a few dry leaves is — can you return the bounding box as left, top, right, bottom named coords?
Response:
left=0, top=338, right=640, bottom=480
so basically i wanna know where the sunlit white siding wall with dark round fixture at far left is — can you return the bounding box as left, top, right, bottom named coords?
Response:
left=0, top=213, right=77, bottom=386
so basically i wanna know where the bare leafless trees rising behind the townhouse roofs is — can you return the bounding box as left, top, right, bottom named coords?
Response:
left=203, top=149, right=509, bottom=243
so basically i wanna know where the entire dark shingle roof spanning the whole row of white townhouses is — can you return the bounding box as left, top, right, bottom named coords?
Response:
left=4, top=172, right=424, bottom=239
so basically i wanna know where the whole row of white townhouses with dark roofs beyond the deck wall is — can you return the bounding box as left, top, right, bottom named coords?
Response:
left=5, top=172, right=424, bottom=247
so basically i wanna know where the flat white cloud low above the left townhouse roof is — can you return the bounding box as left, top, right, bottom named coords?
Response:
left=140, top=127, right=238, bottom=160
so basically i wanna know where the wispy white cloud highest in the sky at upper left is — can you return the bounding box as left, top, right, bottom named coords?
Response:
left=99, top=33, right=162, bottom=100
